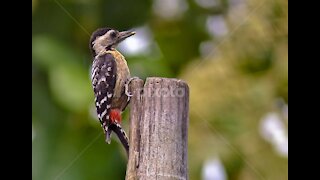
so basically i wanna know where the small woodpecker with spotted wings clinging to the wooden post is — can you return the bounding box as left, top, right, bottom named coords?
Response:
left=89, top=28, right=135, bottom=154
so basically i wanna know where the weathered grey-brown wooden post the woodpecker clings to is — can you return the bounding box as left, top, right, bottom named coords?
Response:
left=126, top=77, right=189, bottom=180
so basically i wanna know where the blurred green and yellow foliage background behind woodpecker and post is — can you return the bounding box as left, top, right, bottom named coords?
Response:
left=32, top=0, right=288, bottom=180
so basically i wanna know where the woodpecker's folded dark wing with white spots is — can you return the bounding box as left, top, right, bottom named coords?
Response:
left=91, top=53, right=117, bottom=129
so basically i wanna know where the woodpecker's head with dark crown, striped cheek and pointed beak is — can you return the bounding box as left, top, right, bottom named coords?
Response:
left=89, top=28, right=135, bottom=57
